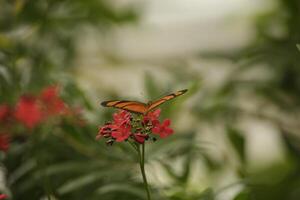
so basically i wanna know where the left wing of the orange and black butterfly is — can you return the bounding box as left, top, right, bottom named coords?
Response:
left=101, top=100, right=147, bottom=114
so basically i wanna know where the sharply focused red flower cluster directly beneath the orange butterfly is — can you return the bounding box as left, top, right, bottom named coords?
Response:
left=96, top=109, right=173, bottom=144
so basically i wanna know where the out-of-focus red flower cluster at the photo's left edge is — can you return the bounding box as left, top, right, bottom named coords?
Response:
left=0, top=86, right=78, bottom=151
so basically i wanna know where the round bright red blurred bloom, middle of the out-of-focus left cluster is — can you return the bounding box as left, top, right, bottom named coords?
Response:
left=15, top=96, right=42, bottom=128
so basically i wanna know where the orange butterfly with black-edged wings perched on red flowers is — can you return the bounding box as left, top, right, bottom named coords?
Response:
left=101, top=89, right=188, bottom=115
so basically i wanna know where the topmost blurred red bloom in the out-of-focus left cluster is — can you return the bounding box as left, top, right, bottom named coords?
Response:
left=40, top=86, right=66, bottom=115
